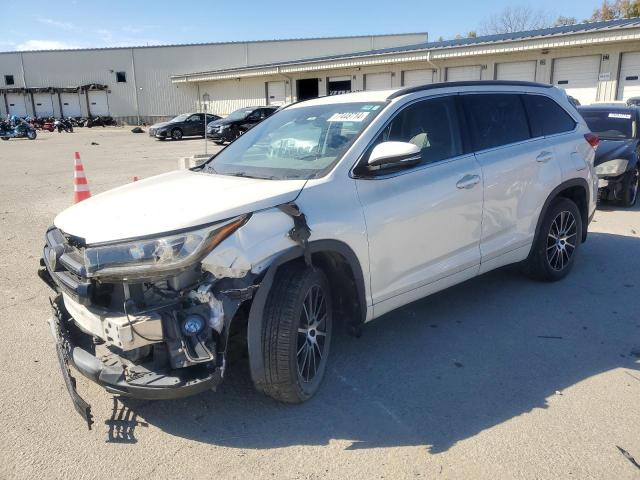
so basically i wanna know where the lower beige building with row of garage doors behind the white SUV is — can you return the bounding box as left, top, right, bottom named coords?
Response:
left=171, top=18, right=640, bottom=114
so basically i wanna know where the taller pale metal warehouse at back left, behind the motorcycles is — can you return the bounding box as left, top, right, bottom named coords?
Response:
left=0, top=33, right=427, bottom=122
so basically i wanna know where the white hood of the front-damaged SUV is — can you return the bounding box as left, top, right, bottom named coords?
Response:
left=54, top=170, right=305, bottom=244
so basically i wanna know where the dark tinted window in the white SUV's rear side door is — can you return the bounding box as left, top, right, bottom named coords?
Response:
left=462, top=93, right=531, bottom=151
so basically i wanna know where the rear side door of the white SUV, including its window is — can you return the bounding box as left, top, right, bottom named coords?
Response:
left=462, top=93, right=561, bottom=271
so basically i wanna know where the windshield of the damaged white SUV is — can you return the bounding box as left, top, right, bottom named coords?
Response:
left=204, top=102, right=384, bottom=180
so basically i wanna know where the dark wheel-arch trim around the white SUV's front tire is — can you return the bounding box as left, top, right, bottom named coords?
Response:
left=247, top=240, right=367, bottom=391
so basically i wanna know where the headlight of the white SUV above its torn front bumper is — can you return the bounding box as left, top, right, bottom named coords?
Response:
left=84, top=215, right=248, bottom=279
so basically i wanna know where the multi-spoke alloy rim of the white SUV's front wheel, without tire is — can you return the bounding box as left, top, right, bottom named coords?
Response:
left=296, top=285, right=328, bottom=382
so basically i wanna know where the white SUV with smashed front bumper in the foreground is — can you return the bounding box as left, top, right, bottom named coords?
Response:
left=40, top=82, right=597, bottom=428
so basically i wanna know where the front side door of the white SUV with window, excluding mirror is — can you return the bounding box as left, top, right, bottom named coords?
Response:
left=356, top=96, right=483, bottom=316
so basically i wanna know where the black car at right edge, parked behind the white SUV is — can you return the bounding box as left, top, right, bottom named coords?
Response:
left=578, top=105, right=640, bottom=207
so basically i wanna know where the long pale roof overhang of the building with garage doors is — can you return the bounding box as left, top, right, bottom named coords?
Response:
left=171, top=25, right=640, bottom=83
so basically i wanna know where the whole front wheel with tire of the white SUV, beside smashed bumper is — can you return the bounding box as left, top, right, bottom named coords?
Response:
left=263, top=263, right=333, bottom=403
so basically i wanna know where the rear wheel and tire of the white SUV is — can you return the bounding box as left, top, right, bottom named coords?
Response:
left=523, top=198, right=583, bottom=282
